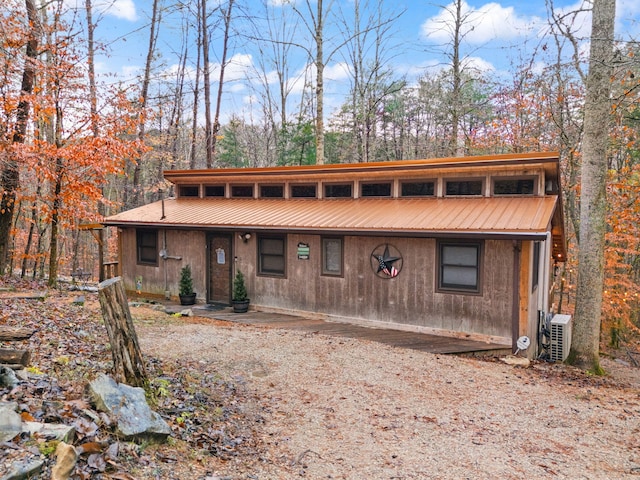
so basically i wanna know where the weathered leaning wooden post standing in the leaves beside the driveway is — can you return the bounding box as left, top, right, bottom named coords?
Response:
left=98, top=277, right=147, bottom=387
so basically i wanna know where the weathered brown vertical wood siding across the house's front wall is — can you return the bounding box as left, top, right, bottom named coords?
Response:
left=121, top=229, right=514, bottom=340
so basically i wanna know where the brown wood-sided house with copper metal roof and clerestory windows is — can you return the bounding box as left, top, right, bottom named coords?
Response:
left=104, top=152, right=566, bottom=358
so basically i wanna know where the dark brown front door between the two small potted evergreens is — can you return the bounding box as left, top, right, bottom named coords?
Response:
left=207, top=233, right=233, bottom=305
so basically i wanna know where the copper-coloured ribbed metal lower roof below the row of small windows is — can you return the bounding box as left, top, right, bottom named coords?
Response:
left=104, top=196, right=558, bottom=237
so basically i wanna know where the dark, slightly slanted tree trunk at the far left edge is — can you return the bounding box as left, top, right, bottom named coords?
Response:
left=0, top=0, right=40, bottom=275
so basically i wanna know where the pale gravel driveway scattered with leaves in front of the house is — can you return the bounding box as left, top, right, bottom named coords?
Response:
left=137, top=320, right=640, bottom=480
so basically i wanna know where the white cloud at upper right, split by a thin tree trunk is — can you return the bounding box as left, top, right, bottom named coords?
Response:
left=421, top=1, right=543, bottom=45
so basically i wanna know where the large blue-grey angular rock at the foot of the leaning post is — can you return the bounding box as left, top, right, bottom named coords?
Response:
left=89, top=374, right=171, bottom=443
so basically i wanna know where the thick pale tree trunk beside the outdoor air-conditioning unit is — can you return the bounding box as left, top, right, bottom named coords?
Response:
left=568, top=0, right=615, bottom=373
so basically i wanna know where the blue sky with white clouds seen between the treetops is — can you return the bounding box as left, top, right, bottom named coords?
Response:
left=68, top=0, right=640, bottom=124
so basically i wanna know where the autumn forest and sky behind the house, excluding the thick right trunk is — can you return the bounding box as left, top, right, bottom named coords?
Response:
left=0, top=0, right=640, bottom=358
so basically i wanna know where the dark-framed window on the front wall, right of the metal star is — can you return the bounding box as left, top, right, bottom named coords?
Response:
left=438, top=242, right=482, bottom=293
